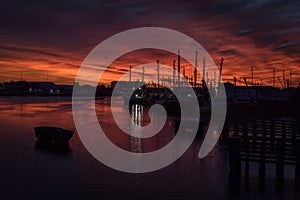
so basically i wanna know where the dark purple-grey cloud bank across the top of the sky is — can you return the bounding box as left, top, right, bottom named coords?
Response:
left=0, top=0, right=298, bottom=49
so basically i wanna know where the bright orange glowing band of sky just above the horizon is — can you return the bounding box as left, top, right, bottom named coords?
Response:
left=0, top=44, right=300, bottom=87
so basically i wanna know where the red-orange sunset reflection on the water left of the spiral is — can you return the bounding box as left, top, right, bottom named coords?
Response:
left=0, top=97, right=74, bottom=130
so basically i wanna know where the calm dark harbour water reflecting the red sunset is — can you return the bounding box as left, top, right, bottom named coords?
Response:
left=0, top=97, right=299, bottom=200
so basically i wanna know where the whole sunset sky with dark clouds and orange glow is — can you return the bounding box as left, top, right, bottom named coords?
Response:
left=0, top=0, right=300, bottom=87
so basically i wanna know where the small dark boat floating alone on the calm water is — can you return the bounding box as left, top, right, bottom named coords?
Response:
left=34, top=126, right=74, bottom=143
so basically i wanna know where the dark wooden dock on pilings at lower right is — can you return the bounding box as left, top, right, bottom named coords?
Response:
left=227, top=120, right=300, bottom=190
